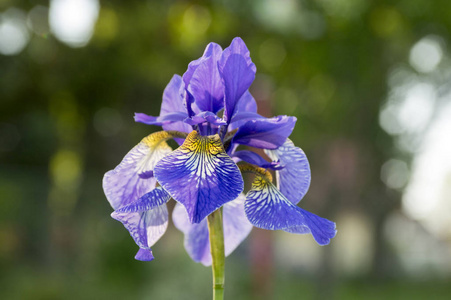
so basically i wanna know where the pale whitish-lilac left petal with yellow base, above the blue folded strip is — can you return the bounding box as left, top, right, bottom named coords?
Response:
left=103, top=131, right=172, bottom=209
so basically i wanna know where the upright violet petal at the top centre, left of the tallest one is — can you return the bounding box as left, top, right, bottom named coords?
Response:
left=188, top=44, right=224, bottom=114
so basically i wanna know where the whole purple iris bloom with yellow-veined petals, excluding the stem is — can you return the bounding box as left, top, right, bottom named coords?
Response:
left=103, top=38, right=336, bottom=265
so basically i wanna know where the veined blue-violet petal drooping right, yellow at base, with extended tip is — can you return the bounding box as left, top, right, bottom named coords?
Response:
left=244, top=175, right=336, bottom=245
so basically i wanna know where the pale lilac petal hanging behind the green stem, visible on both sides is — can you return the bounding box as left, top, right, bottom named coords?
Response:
left=172, top=194, right=252, bottom=266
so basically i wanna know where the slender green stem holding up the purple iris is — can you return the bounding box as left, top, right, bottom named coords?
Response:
left=207, top=209, right=225, bottom=300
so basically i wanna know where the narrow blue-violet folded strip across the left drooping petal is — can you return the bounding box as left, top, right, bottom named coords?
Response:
left=115, top=186, right=171, bottom=214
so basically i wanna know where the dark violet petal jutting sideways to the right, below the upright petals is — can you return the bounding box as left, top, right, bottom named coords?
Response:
left=232, top=116, right=296, bottom=149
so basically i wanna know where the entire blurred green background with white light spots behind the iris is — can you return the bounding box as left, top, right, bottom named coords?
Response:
left=0, top=0, right=451, bottom=299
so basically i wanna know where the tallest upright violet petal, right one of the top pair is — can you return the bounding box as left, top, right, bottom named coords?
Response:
left=218, top=38, right=256, bottom=123
